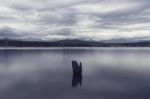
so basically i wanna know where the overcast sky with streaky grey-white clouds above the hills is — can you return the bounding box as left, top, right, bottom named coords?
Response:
left=0, top=0, right=150, bottom=40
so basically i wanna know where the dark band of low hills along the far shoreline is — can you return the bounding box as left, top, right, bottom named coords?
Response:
left=0, top=39, right=150, bottom=47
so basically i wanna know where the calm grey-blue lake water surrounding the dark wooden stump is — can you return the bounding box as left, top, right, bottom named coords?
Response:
left=0, top=48, right=150, bottom=99
